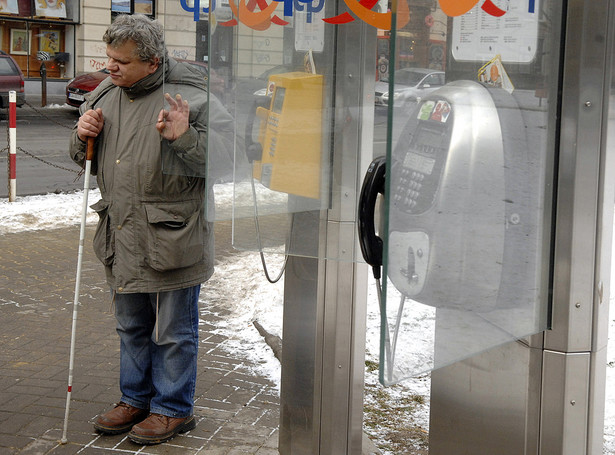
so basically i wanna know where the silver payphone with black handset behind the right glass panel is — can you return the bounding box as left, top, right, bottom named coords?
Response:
left=359, top=81, right=541, bottom=313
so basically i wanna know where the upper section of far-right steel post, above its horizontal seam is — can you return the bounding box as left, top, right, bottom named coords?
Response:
left=546, top=0, right=610, bottom=352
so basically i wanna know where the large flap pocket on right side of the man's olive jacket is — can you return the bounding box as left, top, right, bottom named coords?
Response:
left=145, top=201, right=205, bottom=272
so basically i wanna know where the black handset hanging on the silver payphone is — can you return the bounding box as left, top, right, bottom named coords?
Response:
left=359, top=156, right=386, bottom=280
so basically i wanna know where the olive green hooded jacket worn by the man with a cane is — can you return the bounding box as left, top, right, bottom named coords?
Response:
left=70, top=58, right=233, bottom=293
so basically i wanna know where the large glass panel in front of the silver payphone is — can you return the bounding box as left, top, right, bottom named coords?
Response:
left=377, top=0, right=562, bottom=384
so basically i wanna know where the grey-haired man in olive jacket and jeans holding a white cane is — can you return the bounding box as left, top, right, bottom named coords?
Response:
left=70, top=15, right=232, bottom=444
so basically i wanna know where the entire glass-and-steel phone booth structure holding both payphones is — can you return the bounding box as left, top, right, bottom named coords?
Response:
left=162, top=0, right=615, bottom=455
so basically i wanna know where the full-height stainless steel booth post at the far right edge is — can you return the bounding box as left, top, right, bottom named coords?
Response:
left=540, top=0, right=615, bottom=455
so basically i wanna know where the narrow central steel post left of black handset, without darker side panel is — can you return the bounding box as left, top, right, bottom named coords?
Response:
left=318, top=16, right=376, bottom=454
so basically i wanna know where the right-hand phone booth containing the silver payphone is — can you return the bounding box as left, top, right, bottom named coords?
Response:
left=366, top=1, right=614, bottom=455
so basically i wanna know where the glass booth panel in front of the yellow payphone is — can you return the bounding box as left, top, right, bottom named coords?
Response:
left=159, top=0, right=337, bottom=256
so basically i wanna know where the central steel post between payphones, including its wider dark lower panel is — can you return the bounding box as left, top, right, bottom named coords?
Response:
left=279, top=8, right=376, bottom=455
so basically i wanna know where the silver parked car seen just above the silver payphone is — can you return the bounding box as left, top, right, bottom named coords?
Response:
left=375, top=68, right=445, bottom=106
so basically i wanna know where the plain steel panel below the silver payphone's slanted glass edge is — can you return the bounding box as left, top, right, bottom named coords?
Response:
left=429, top=342, right=551, bottom=455
